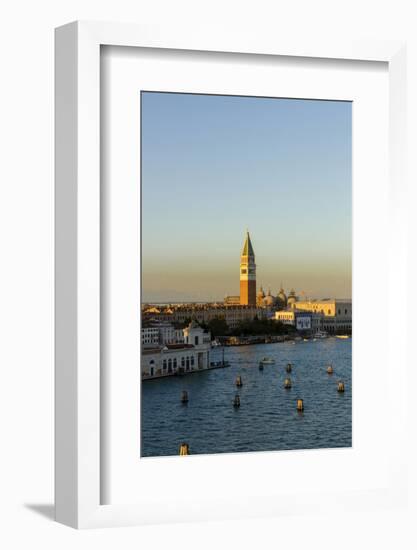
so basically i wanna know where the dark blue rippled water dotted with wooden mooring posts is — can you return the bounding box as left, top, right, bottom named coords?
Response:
left=141, top=338, right=352, bottom=456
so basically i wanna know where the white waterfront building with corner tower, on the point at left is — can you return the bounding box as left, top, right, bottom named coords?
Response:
left=141, top=321, right=211, bottom=379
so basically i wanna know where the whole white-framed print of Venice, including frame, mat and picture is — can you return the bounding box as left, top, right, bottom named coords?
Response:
left=56, top=23, right=406, bottom=527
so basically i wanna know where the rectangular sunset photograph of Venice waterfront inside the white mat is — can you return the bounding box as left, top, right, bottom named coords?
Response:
left=138, top=91, right=352, bottom=458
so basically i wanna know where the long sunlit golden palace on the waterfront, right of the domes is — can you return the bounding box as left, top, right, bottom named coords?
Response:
left=291, top=298, right=352, bottom=334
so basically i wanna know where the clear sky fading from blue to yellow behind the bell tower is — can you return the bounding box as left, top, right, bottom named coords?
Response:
left=141, top=92, right=352, bottom=301
